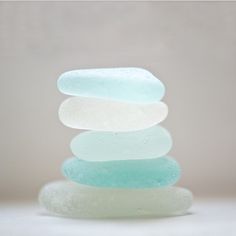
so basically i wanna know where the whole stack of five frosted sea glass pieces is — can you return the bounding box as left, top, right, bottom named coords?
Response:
left=39, top=68, right=192, bottom=218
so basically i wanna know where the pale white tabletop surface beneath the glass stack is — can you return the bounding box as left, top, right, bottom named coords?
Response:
left=0, top=198, right=236, bottom=236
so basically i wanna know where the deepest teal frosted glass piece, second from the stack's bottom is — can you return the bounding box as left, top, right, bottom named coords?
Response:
left=62, top=157, right=180, bottom=188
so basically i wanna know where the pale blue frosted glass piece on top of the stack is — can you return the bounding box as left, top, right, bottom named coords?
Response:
left=57, top=67, right=165, bottom=103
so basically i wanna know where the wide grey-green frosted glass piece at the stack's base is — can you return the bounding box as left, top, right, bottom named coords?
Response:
left=39, top=181, right=192, bottom=218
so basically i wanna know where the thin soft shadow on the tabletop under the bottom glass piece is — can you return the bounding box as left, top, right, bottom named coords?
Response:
left=37, top=211, right=195, bottom=223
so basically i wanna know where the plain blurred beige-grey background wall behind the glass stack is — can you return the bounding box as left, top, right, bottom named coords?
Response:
left=0, top=2, right=236, bottom=199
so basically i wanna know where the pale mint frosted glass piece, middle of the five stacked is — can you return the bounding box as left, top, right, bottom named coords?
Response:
left=70, top=125, right=172, bottom=161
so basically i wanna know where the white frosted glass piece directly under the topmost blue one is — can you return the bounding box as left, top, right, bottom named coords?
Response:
left=59, top=97, right=168, bottom=132
